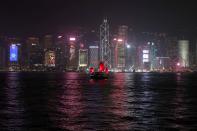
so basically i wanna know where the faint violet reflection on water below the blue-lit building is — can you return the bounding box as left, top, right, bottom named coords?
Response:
left=0, top=73, right=24, bottom=131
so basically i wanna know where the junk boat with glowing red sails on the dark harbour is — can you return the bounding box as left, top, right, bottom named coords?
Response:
left=89, top=62, right=109, bottom=79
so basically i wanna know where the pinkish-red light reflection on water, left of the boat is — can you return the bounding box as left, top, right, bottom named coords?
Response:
left=50, top=73, right=84, bottom=130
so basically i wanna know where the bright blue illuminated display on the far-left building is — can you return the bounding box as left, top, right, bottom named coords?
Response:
left=10, top=44, right=18, bottom=62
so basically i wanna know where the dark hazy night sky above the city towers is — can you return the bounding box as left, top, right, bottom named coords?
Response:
left=0, top=0, right=197, bottom=35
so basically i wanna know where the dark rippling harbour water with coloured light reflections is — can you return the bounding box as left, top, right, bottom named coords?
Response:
left=0, top=73, right=197, bottom=131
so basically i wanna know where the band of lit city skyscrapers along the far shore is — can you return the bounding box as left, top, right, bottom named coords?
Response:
left=0, top=26, right=194, bottom=72
